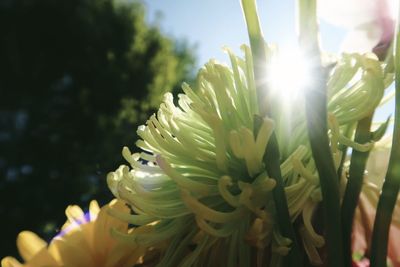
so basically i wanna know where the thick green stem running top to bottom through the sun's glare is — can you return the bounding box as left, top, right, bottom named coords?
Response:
left=298, top=0, right=344, bottom=267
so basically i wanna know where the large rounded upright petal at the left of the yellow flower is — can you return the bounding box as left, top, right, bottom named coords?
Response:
left=17, top=231, right=47, bottom=261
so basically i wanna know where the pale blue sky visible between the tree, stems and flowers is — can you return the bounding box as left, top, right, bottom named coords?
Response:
left=144, top=0, right=393, bottom=121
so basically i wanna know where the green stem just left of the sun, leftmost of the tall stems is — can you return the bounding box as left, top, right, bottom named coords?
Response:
left=241, top=0, right=302, bottom=266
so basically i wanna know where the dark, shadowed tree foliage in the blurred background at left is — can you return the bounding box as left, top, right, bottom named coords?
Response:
left=0, top=0, right=193, bottom=257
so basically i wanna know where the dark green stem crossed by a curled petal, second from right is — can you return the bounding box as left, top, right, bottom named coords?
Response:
left=342, top=115, right=372, bottom=267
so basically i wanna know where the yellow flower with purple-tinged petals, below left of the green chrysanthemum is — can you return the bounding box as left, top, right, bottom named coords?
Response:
left=1, top=200, right=152, bottom=267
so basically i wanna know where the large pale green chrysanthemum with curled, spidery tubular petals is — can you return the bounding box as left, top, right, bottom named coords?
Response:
left=108, top=46, right=387, bottom=266
